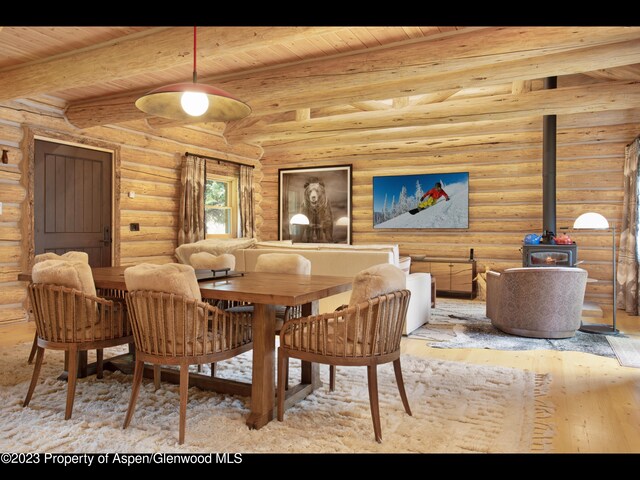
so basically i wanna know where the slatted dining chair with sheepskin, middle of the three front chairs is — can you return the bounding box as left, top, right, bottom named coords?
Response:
left=123, top=264, right=253, bottom=444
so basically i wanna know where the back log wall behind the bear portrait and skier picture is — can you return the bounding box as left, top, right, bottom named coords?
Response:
left=260, top=111, right=640, bottom=305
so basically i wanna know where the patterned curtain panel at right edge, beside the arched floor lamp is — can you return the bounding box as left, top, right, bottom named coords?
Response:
left=616, top=137, right=640, bottom=315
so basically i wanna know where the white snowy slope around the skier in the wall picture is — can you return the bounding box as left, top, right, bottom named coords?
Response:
left=374, top=176, right=469, bottom=228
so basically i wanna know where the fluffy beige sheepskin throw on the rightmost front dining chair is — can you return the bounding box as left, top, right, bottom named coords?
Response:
left=349, top=263, right=407, bottom=307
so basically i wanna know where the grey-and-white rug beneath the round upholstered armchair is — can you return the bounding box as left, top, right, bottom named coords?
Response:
left=409, top=298, right=615, bottom=358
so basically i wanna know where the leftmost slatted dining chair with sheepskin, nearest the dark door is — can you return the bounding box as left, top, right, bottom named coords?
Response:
left=23, top=260, right=133, bottom=420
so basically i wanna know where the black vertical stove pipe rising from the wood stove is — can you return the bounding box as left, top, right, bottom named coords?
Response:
left=542, top=77, right=558, bottom=239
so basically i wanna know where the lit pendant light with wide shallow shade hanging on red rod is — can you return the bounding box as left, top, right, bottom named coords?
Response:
left=136, top=27, right=251, bottom=122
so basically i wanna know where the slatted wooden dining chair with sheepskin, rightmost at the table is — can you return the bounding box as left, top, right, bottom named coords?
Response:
left=277, top=264, right=411, bottom=442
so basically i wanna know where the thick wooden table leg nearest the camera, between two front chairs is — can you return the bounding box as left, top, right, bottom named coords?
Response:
left=247, top=303, right=276, bottom=429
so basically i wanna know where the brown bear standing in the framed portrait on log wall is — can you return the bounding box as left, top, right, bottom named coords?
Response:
left=301, top=177, right=333, bottom=243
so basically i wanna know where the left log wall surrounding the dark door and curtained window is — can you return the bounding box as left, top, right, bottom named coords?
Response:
left=0, top=102, right=262, bottom=324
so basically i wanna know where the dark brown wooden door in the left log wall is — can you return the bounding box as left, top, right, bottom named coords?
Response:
left=34, top=140, right=112, bottom=267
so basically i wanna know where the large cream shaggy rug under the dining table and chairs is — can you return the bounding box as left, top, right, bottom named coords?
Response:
left=0, top=344, right=553, bottom=453
